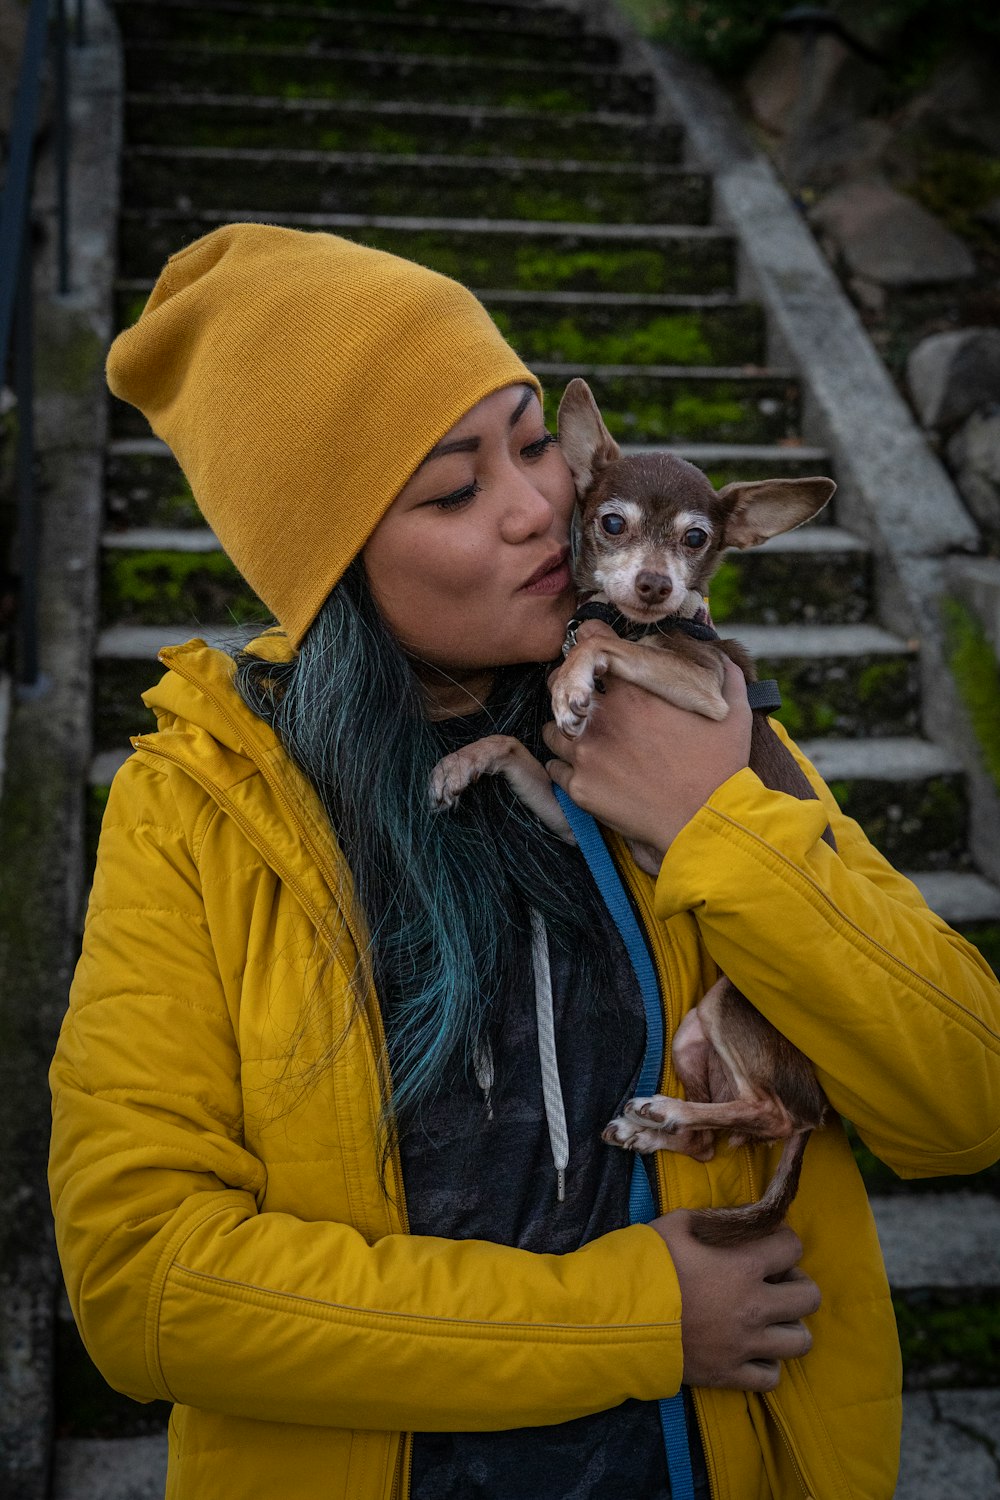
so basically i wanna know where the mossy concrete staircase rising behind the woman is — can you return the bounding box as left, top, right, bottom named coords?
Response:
left=57, top=0, right=1000, bottom=1500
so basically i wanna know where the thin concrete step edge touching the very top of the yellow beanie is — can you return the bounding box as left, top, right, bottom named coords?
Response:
left=120, top=209, right=733, bottom=245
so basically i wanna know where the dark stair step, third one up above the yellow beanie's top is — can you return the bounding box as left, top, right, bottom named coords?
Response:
left=124, top=42, right=654, bottom=114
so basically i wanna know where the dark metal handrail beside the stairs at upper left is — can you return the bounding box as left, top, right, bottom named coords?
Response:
left=0, top=0, right=84, bottom=689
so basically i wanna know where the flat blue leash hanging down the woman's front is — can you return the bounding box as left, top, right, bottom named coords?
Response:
left=553, top=786, right=694, bottom=1500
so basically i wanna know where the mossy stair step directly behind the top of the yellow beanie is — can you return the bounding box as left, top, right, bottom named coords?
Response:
left=120, top=210, right=735, bottom=294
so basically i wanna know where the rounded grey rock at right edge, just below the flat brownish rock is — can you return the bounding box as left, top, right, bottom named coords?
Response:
left=906, top=329, right=1000, bottom=431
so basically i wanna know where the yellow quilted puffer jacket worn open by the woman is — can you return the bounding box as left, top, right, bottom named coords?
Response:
left=51, top=636, right=1000, bottom=1500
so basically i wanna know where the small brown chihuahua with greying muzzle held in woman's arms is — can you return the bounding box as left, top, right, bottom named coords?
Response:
left=432, top=380, right=837, bottom=1245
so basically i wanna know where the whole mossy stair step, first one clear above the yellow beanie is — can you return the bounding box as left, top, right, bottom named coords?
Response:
left=123, top=146, right=711, bottom=225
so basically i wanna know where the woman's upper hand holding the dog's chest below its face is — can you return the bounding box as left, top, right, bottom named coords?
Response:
left=543, top=633, right=753, bottom=860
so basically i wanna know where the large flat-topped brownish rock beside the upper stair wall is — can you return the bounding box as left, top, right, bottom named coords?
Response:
left=810, top=179, right=976, bottom=287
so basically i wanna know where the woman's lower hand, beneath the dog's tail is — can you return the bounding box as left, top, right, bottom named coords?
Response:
left=651, top=1209, right=820, bottom=1391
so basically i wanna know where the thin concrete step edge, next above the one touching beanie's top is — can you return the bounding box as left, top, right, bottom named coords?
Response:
left=121, top=146, right=711, bottom=183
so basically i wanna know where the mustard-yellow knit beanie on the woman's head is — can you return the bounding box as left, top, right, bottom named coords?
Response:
left=108, top=224, right=541, bottom=645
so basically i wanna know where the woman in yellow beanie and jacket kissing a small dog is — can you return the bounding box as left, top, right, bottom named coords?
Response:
left=51, top=225, right=1000, bottom=1500
